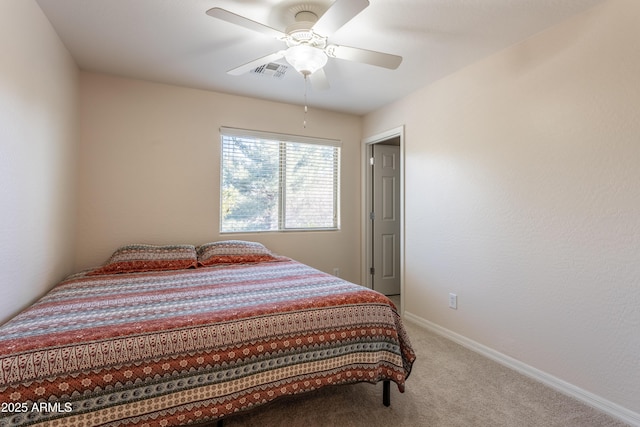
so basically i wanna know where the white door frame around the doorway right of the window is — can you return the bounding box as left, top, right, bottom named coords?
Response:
left=360, top=125, right=405, bottom=315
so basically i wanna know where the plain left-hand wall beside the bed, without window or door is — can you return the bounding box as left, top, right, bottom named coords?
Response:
left=0, top=0, right=78, bottom=323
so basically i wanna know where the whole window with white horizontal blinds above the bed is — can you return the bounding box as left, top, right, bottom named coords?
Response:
left=220, top=128, right=340, bottom=233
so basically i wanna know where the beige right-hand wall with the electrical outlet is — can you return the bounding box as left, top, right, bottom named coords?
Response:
left=363, top=0, right=640, bottom=420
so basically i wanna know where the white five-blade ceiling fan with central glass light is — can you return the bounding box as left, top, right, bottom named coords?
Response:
left=207, top=0, right=402, bottom=89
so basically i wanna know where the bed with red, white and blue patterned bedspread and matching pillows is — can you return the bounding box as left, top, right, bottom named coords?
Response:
left=0, top=241, right=415, bottom=427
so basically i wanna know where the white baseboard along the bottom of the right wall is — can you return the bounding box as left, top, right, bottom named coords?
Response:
left=404, top=311, right=640, bottom=427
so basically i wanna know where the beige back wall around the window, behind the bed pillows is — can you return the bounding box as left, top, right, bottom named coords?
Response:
left=76, top=72, right=361, bottom=282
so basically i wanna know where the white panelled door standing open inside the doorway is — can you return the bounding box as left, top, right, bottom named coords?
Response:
left=370, top=144, right=401, bottom=295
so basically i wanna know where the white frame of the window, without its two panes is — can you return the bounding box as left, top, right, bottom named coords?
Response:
left=218, top=127, right=342, bottom=234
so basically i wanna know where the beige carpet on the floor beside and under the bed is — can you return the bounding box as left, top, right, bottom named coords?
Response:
left=216, top=316, right=626, bottom=427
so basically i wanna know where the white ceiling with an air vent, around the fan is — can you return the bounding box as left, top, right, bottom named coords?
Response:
left=37, top=0, right=603, bottom=114
